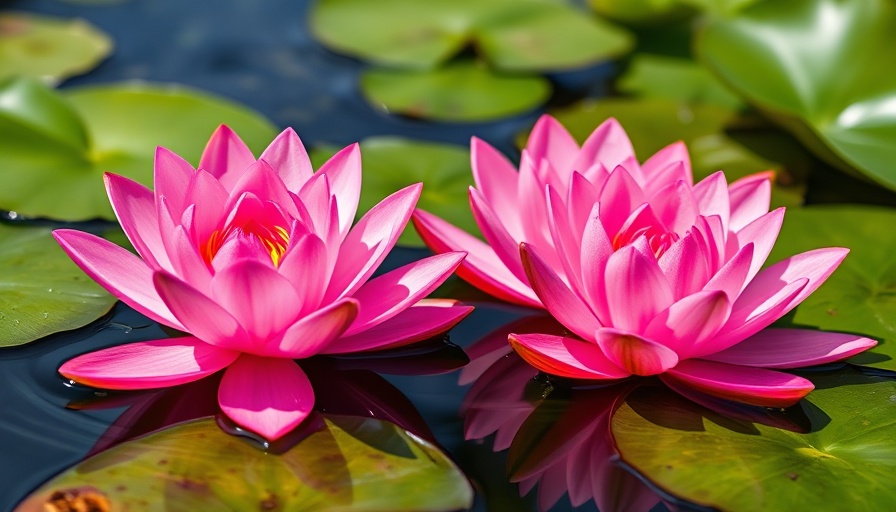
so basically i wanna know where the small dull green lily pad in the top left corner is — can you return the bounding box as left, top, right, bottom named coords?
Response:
left=0, top=12, right=112, bottom=82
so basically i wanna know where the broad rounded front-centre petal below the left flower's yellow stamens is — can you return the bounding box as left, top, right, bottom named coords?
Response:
left=211, top=260, right=301, bottom=343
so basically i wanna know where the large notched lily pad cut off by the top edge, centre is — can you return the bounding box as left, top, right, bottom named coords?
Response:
left=310, top=0, right=632, bottom=71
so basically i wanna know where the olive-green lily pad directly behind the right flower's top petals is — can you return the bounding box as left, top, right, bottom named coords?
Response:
left=536, top=98, right=806, bottom=206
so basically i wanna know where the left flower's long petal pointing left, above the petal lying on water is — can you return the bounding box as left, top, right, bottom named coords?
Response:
left=53, top=229, right=184, bottom=330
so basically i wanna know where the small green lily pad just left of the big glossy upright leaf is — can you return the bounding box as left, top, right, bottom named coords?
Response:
left=617, top=53, right=744, bottom=110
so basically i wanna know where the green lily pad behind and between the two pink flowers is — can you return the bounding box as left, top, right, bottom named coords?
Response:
left=311, top=137, right=479, bottom=247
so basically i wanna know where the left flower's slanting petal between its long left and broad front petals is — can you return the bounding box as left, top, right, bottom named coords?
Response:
left=153, top=271, right=251, bottom=351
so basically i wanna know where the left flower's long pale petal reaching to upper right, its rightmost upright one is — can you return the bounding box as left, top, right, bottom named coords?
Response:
left=324, top=184, right=421, bottom=302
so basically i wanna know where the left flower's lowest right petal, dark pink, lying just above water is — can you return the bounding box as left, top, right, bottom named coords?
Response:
left=322, top=299, right=473, bottom=354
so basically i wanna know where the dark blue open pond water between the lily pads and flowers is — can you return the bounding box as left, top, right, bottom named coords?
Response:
left=0, top=0, right=728, bottom=510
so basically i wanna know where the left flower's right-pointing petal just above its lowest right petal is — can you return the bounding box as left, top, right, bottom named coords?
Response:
left=345, top=252, right=466, bottom=336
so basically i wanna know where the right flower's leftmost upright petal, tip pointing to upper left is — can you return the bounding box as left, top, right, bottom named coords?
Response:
left=470, top=137, right=523, bottom=240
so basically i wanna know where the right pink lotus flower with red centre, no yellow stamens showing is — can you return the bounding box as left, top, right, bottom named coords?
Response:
left=414, top=116, right=876, bottom=406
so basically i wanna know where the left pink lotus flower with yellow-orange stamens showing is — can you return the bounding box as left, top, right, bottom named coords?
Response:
left=55, top=126, right=472, bottom=440
